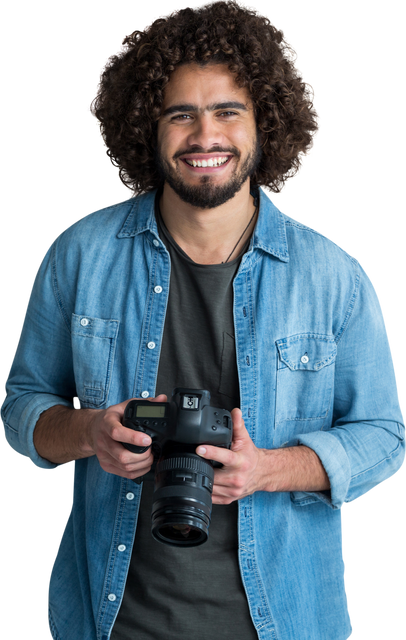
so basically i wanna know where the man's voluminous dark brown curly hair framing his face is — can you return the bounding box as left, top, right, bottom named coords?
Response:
left=85, top=0, right=323, bottom=197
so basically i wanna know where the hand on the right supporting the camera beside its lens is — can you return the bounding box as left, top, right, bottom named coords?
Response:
left=196, top=409, right=262, bottom=504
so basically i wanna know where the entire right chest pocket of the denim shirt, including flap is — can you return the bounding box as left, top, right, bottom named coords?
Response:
left=275, top=333, right=337, bottom=430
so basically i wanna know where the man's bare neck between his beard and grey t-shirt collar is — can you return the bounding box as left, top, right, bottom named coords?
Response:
left=159, top=183, right=258, bottom=264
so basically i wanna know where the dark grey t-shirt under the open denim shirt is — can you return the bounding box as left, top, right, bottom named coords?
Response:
left=111, top=190, right=258, bottom=640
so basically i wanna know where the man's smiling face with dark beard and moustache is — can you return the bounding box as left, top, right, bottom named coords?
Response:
left=154, top=63, right=262, bottom=209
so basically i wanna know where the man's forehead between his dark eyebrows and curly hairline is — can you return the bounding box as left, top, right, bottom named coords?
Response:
left=164, top=63, right=251, bottom=106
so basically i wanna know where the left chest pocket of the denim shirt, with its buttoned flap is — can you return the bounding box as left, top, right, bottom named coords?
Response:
left=71, top=313, right=120, bottom=409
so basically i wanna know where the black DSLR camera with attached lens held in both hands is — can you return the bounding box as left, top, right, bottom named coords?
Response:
left=122, top=388, right=233, bottom=547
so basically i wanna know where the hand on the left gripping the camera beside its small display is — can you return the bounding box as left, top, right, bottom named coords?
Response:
left=88, top=394, right=167, bottom=480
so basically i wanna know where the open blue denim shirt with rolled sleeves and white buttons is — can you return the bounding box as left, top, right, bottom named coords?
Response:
left=1, top=188, right=406, bottom=640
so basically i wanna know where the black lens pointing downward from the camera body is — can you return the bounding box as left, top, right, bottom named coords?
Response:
left=151, top=448, right=214, bottom=547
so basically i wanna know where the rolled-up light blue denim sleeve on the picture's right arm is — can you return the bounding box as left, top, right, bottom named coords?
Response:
left=287, top=260, right=406, bottom=509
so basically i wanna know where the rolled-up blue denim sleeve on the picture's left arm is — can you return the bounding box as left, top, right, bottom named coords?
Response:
left=0, top=234, right=76, bottom=471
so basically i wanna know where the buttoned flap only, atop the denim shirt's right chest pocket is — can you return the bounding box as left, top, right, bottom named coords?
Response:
left=276, top=333, right=337, bottom=371
